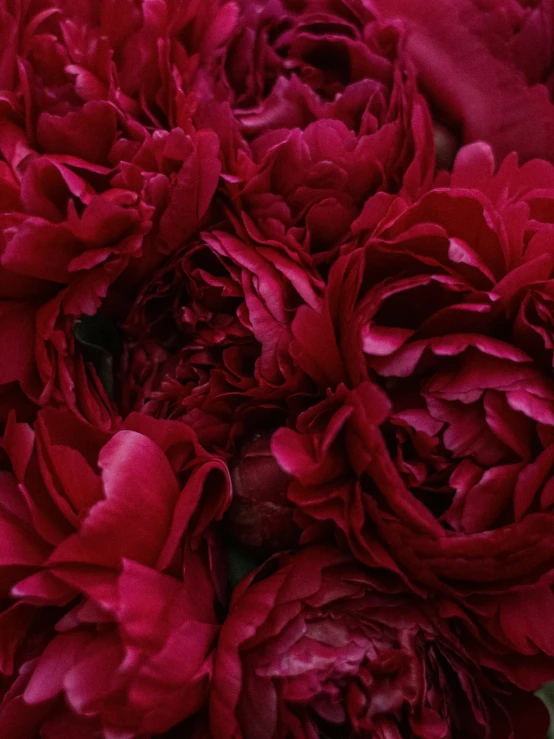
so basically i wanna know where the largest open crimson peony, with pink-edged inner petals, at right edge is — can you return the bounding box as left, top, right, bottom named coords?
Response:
left=272, top=145, right=554, bottom=655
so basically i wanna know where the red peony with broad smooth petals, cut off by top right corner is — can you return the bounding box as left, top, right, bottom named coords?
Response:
left=366, top=0, right=554, bottom=161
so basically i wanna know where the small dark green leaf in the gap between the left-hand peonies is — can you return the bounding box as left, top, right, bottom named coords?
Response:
left=73, top=315, right=121, bottom=398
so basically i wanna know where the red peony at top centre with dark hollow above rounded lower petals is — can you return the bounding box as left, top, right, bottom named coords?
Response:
left=208, top=0, right=434, bottom=262
